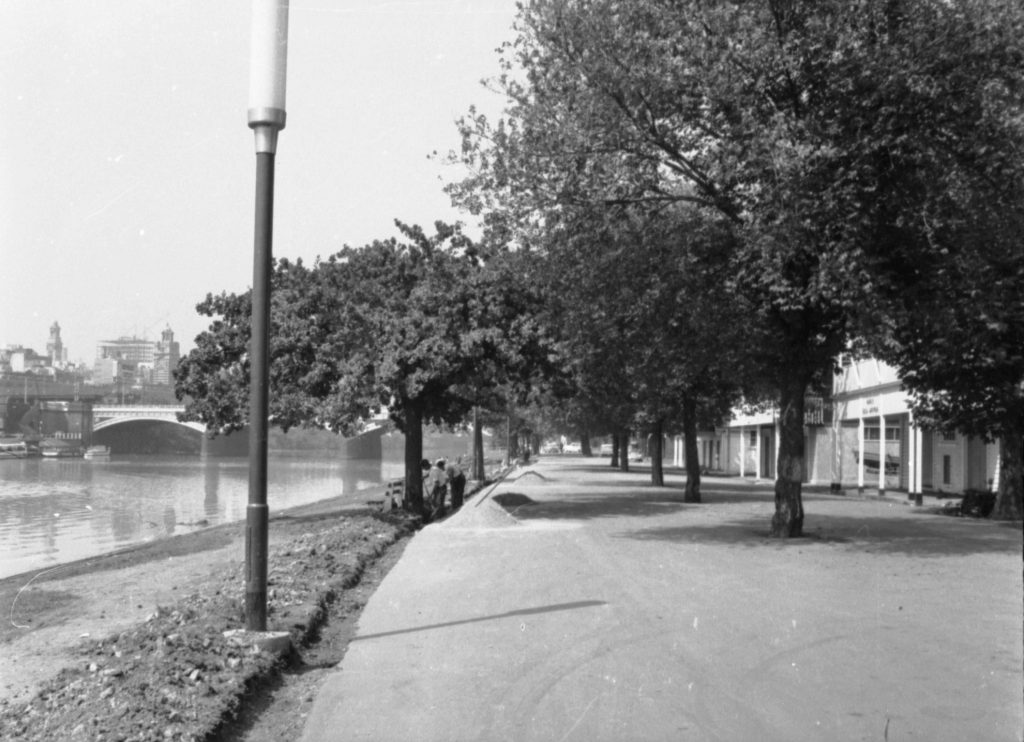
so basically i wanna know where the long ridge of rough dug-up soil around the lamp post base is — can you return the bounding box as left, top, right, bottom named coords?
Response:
left=0, top=512, right=418, bottom=742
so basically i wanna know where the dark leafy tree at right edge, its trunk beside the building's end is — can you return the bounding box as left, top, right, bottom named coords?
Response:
left=865, top=198, right=1024, bottom=520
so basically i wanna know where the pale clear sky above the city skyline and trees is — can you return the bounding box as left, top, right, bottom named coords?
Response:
left=0, top=0, right=515, bottom=363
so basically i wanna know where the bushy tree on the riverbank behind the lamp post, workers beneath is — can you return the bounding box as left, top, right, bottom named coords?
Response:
left=175, top=223, right=557, bottom=513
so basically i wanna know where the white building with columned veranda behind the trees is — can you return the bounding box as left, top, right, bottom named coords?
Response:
left=674, top=358, right=999, bottom=494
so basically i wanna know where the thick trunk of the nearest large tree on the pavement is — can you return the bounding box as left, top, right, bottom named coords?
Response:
left=771, top=380, right=807, bottom=538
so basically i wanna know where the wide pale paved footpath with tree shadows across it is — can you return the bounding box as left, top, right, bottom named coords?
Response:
left=302, top=455, right=1024, bottom=742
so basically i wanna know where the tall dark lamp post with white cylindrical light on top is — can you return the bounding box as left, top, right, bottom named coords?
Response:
left=246, top=0, right=288, bottom=631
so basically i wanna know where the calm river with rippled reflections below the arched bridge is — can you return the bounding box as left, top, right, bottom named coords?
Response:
left=0, top=451, right=419, bottom=577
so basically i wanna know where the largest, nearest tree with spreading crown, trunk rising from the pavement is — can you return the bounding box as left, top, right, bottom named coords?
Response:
left=453, top=0, right=1021, bottom=536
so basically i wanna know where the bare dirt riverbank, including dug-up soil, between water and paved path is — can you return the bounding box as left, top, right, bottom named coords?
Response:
left=0, top=491, right=417, bottom=741
